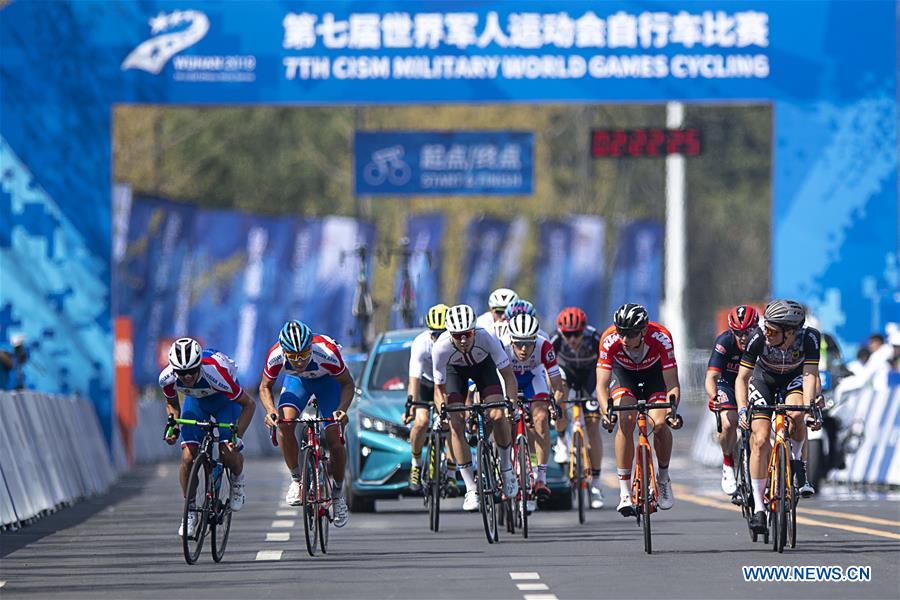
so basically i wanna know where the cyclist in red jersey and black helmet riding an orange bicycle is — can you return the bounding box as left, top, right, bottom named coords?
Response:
left=597, top=304, right=681, bottom=517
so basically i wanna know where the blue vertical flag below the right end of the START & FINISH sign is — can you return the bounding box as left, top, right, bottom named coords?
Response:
left=460, top=217, right=509, bottom=314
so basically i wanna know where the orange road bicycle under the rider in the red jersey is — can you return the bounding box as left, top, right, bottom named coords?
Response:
left=607, top=394, right=684, bottom=554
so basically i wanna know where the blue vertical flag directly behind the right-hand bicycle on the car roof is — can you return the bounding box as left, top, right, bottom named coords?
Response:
left=390, top=213, right=447, bottom=329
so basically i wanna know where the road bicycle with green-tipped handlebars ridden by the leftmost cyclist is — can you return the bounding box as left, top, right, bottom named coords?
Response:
left=166, top=415, right=238, bottom=565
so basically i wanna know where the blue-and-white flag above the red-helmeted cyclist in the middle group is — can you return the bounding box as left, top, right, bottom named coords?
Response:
left=534, top=215, right=606, bottom=331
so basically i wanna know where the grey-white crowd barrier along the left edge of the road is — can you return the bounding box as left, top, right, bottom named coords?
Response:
left=0, top=392, right=118, bottom=527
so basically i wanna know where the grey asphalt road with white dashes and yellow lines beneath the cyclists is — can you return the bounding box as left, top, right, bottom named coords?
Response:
left=0, top=441, right=900, bottom=600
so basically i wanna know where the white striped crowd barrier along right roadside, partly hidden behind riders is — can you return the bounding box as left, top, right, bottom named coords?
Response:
left=691, top=386, right=900, bottom=486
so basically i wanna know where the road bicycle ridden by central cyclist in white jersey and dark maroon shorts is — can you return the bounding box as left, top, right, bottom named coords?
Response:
left=441, top=400, right=510, bottom=544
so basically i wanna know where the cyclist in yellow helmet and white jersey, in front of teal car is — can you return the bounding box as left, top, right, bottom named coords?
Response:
left=403, top=304, right=450, bottom=492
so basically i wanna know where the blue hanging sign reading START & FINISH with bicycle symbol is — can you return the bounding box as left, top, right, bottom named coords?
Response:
left=353, top=131, right=534, bottom=196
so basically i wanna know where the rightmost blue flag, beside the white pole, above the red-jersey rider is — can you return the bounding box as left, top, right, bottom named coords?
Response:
left=603, top=220, right=663, bottom=322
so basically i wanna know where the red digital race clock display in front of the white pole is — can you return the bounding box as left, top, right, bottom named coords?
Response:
left=591, top=127, right=702, bottom=158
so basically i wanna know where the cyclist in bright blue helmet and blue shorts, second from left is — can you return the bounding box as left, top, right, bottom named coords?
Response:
left=259, top=321, right=356, bottom=527
